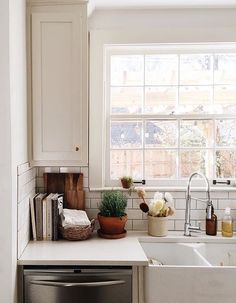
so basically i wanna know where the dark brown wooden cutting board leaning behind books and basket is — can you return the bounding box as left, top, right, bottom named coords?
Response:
left=43, top=173, right=85, bottom=210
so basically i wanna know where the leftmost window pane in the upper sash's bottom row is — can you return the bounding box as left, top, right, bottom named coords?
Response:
left=111, top=87, right=143, bottom=114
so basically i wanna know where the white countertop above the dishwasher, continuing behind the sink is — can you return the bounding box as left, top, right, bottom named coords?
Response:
left=18, top=231, right=236, bottom=266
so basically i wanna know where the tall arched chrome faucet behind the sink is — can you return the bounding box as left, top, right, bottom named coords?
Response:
left=184, top=172, right=212, bottom=236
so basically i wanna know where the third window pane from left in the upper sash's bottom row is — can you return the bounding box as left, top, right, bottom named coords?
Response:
left=179, top=86, right=212, bottom=113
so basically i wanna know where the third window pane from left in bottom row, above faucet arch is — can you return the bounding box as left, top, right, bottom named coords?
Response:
left=180, top=150, right=211, bottom=178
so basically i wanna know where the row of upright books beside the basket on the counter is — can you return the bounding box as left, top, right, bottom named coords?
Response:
left=30, top=193, right=63, bottom=241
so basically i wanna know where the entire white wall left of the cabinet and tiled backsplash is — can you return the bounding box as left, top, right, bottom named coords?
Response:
left=0, top=0, right=28, bottom=303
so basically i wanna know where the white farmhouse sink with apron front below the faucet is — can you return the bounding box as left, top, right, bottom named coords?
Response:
left=140, top=238, right=236, bottom=303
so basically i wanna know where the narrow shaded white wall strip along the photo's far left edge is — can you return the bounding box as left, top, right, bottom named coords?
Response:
left=0, top=0, right=13, bottom=302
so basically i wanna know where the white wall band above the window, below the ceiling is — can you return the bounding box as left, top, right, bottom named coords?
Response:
left=89, top=9, right=236, bottom=43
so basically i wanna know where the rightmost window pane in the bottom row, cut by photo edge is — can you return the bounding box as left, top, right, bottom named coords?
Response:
left=216, top=150, right=236, bottom=178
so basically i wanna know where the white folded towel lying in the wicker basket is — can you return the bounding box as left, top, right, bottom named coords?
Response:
left=61, top=208, right=91, bottom=228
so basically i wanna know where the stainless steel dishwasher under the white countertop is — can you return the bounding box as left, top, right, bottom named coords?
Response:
left=24, top=266, right=132, bottom=303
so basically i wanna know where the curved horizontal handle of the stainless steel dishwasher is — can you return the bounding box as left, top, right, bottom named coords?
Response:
left=30, top=280, right=125, bottom=287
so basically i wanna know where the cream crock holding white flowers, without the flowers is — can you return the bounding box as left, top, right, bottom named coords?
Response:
left=148, top=216, right=168, bottom=237
